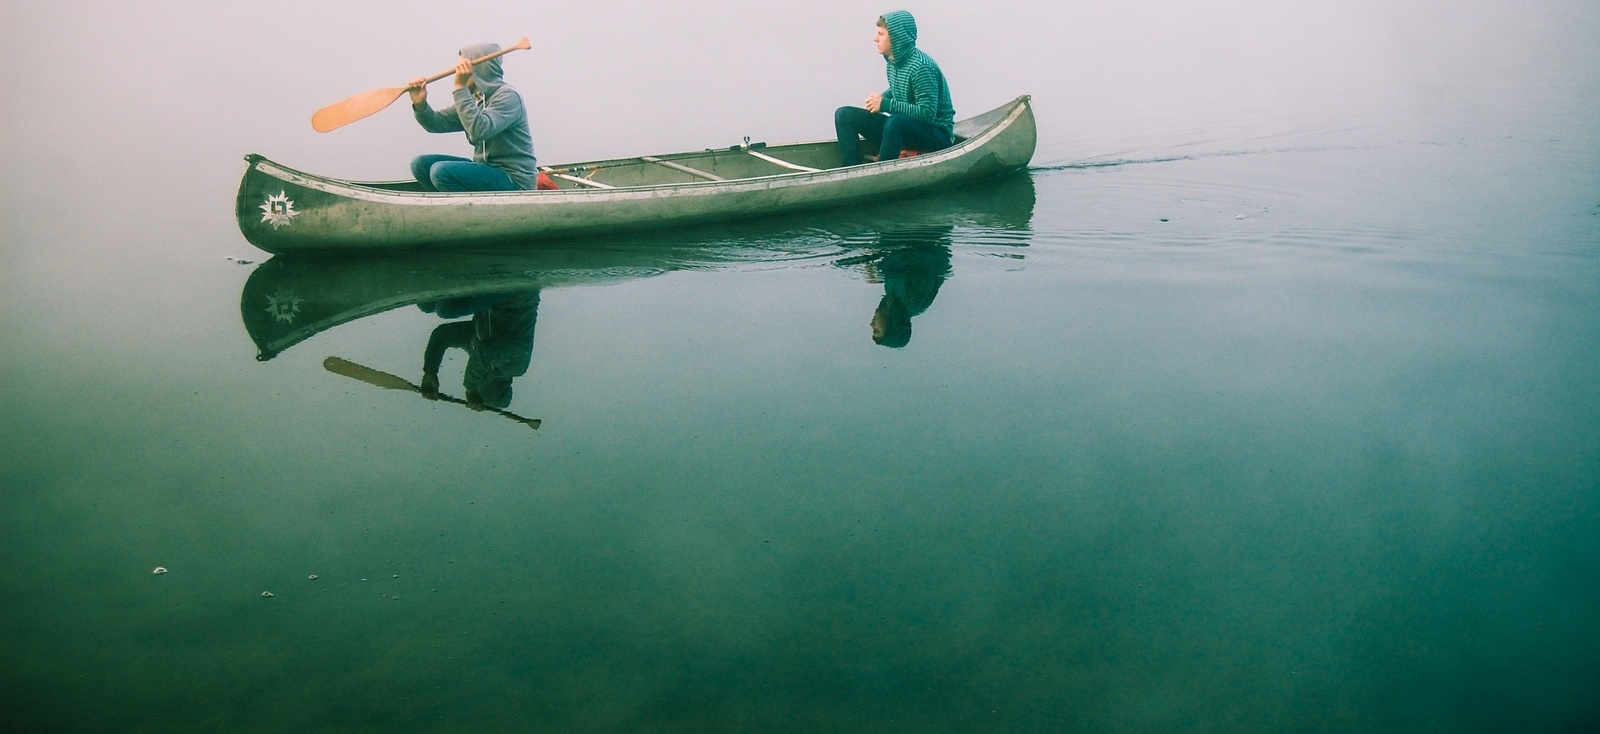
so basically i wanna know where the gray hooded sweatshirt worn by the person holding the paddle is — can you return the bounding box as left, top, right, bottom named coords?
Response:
left=411, top=43, right=539, bottom=189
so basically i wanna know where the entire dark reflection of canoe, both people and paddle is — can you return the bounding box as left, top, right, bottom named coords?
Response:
left=238, top=173, right=1034, bottom=427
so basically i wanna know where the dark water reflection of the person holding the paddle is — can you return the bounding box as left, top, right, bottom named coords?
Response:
left=418, top=291, right=539, bottom=411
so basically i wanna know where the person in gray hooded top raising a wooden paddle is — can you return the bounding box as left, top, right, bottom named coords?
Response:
left=410, top=43, right=539, bottom=192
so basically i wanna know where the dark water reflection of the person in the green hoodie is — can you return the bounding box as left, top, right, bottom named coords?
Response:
left=866, top=227, right=950, bottom=349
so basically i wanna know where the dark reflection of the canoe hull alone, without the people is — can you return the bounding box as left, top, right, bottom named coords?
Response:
left=238, top=173, right=1035, bottom=361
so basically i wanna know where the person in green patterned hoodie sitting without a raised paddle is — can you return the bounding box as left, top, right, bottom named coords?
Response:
left=834, top=10, right=955, bottom=166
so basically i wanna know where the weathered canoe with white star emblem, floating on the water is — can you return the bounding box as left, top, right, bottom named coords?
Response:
left=235, top=96, right=1037, bottom=254
